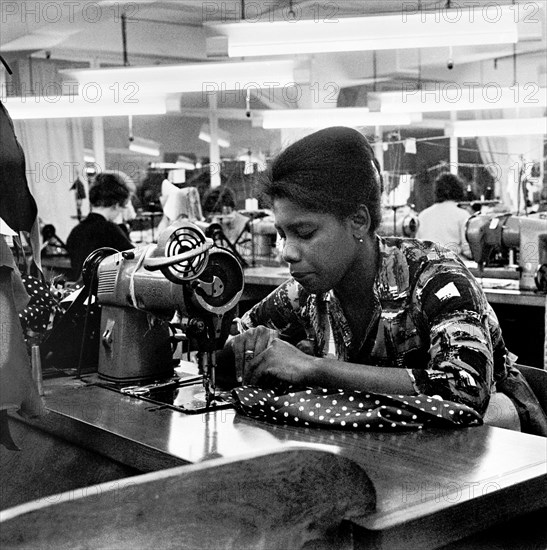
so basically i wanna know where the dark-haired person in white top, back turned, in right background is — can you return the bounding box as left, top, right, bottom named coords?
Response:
left=416, top=173, right=471, bottom=258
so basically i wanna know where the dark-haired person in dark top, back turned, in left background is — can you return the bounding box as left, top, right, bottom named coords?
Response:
left=66, top=172, right=134, bottom=279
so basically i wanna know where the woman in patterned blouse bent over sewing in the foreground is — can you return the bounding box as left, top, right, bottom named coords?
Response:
left=217, top=127, right=547, bottom=433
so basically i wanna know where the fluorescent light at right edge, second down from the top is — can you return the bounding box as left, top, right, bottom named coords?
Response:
left=369, top=87, right=547, bottom=113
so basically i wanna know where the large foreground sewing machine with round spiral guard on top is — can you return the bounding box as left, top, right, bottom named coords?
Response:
left=88, top=221, right=243, bottom=410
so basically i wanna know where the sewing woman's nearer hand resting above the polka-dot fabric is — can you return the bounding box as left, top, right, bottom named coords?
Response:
left=243, top=338, right=315, bottom=387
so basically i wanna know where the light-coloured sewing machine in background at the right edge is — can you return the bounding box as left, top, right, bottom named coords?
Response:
left=466, top=212, right=547, bottom=291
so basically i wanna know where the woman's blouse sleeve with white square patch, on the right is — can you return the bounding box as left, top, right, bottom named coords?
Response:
left=411, top=260, right=494, bottom=414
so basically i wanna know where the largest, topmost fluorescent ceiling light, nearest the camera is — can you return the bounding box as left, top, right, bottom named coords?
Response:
left=207, top=6, right=524, bottom=57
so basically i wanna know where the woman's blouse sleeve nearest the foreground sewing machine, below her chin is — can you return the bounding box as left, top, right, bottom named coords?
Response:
left=241, top=279, right=307, bottom=341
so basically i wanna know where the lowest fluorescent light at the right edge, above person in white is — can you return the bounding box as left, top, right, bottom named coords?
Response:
left=445, top=117, right=547, bottom=137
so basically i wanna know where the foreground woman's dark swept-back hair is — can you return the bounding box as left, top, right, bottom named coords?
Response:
left=258, top=126, right=383, bottom=234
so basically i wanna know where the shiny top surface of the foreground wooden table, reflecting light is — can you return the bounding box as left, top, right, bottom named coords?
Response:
left=39, top=378, right=547, bottom=530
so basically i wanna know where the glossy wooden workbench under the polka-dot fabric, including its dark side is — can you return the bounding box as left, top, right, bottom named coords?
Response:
left=5, top=378, right=547, bottom=550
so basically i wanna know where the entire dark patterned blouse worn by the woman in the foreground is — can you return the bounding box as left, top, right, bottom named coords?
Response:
left=242, top=237, right=514, bottom=414
